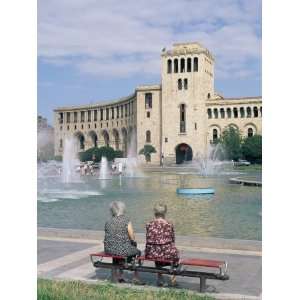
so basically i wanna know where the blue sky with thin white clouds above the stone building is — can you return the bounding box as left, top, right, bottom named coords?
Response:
left=37, top=0, right=261, bottom=124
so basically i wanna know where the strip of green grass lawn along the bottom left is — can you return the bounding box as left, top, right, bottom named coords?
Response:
left=37, top=279, right=214, bottom=300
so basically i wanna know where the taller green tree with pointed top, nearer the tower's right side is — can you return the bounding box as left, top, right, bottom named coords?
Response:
left=220, top=125, right=242, bottom=161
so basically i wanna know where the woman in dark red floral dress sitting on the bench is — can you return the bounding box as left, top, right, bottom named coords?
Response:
left=145, top=204, right=179, bottom=286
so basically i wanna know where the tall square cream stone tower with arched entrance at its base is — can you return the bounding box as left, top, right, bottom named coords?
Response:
left=161, top=43, right=214, bottom=163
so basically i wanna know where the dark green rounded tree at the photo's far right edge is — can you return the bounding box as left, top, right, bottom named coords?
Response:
left=242, top=135, right=262, bottom=164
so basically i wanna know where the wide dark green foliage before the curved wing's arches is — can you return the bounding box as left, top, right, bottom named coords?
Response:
left=79, top=146, right=123, bottom=162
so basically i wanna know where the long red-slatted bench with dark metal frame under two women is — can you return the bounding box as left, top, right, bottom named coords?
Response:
left=90, top=252, right=229, bottom=292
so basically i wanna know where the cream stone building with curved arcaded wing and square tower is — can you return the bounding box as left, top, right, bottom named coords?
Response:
left=54, top=42, right=262, bottom=163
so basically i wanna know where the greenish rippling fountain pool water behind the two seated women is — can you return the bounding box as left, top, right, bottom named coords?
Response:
left=38, top=173, right=261, bottom=240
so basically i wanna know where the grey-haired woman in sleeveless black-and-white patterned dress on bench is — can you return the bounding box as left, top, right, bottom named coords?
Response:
left=104, top=201, right=142, bottom=284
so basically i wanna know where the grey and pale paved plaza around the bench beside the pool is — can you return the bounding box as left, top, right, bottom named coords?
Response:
left=38, top=228, right=262, bottom=300
